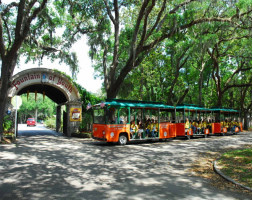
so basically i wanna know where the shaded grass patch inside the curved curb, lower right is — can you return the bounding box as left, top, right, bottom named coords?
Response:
left=217, top=148, right=252, bottom=187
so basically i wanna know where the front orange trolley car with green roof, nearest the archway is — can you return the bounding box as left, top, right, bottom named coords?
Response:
left=92, top=99, right=176, bottom=145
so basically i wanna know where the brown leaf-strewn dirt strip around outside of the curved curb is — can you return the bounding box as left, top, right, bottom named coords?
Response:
left=189, top=145, right=252, bottom=194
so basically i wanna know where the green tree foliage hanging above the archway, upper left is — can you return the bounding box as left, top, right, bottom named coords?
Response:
left=0, top=0, right=88, bottom=77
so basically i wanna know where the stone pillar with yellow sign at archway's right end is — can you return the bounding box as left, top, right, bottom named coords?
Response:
left=66, top=102, right=82, bottom=137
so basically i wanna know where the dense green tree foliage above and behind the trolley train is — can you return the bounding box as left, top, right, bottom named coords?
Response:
left=105, top=0, right=252, bottom=112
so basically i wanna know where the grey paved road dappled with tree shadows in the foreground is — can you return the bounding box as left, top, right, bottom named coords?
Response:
left=0, top=126, right=252, bottom=200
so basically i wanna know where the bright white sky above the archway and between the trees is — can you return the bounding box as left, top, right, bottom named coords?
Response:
left=14, top=36, right=103, bottom=93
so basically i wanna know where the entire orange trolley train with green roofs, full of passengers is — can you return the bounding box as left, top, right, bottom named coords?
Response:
left=92, top=99, right=242, bottom=145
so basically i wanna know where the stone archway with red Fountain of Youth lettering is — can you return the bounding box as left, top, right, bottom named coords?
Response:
left=8, top=68, right=82, bottom=136
